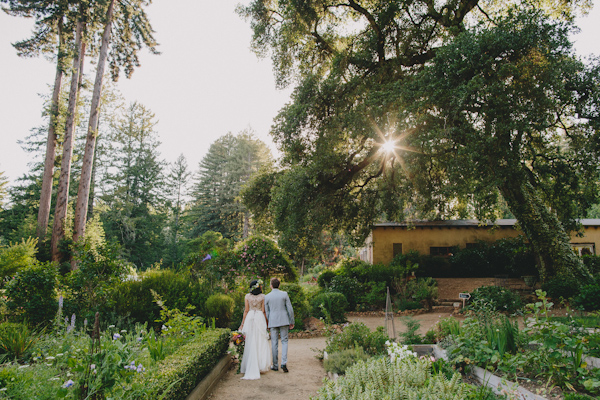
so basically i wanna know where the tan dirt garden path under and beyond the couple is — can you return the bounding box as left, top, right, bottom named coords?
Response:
left=209, top=314, right=450, bottom=400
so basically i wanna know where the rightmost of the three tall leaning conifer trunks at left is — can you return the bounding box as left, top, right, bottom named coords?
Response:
left=73, top=0, right=115, bottom=250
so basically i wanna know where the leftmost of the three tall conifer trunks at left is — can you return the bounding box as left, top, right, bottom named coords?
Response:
left=36, top=23, right=64, bottom=249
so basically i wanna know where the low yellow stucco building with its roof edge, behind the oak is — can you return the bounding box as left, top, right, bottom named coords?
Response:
left=360, top=219, right=600, bottom=264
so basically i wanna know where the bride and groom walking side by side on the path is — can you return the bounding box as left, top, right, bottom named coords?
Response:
left=239, top=278, right=294, bottom=379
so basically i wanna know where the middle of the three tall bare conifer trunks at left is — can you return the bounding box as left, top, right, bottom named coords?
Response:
left=50, top=21, right=85, bottom=261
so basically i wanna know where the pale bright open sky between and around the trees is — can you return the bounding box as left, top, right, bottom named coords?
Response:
left=0, top=0, right=600, bottom=187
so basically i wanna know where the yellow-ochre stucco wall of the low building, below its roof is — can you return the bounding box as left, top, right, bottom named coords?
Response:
left=365, top=226, right=600, bottom=264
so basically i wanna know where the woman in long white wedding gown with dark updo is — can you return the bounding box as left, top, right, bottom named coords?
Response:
left=239, top=279, right=271, bottom=379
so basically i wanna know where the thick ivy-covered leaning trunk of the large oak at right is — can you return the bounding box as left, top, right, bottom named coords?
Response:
left=499, top=177, right=590, bottom=281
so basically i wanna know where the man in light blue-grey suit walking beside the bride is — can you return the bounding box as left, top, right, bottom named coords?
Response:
left=265, top=278, right=294, bottom=372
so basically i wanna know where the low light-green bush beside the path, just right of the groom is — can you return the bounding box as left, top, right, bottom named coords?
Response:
left=325, top=322, right=389, bottom=356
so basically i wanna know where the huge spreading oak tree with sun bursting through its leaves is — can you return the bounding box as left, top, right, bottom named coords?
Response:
left=240, top=0, right=599, bottom=276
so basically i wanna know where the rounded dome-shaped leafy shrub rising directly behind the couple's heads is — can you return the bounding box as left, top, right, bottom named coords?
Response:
left=235, top=236, right=298, bottom=282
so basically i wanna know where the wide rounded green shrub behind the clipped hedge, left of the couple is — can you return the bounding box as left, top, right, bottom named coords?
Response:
left=109, top=269, right=208, bottom=328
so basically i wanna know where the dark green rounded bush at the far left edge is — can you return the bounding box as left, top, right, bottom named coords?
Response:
left=6, top=263, right=58, bottom=325
